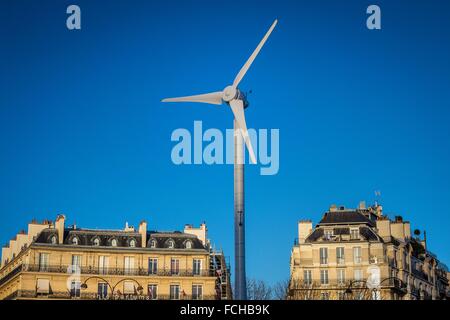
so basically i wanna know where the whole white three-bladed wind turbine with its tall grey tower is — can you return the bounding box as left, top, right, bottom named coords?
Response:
left=162, top=20, right=278, bottom=300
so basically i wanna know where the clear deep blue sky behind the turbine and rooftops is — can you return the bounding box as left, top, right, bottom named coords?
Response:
left=0, top=0, right=450, bottom=282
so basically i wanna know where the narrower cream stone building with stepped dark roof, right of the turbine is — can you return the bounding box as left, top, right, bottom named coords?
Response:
left=288, top=202, right=448, bottom=300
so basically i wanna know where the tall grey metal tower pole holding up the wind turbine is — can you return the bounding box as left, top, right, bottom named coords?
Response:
left=234, top=120, right=247, bottom=300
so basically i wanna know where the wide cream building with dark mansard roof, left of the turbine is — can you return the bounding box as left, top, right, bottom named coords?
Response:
left=0, top=215, right=231, bottom=300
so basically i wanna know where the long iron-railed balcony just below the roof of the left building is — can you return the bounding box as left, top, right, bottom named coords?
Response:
left=20, top=264, right=215, bottom=281
